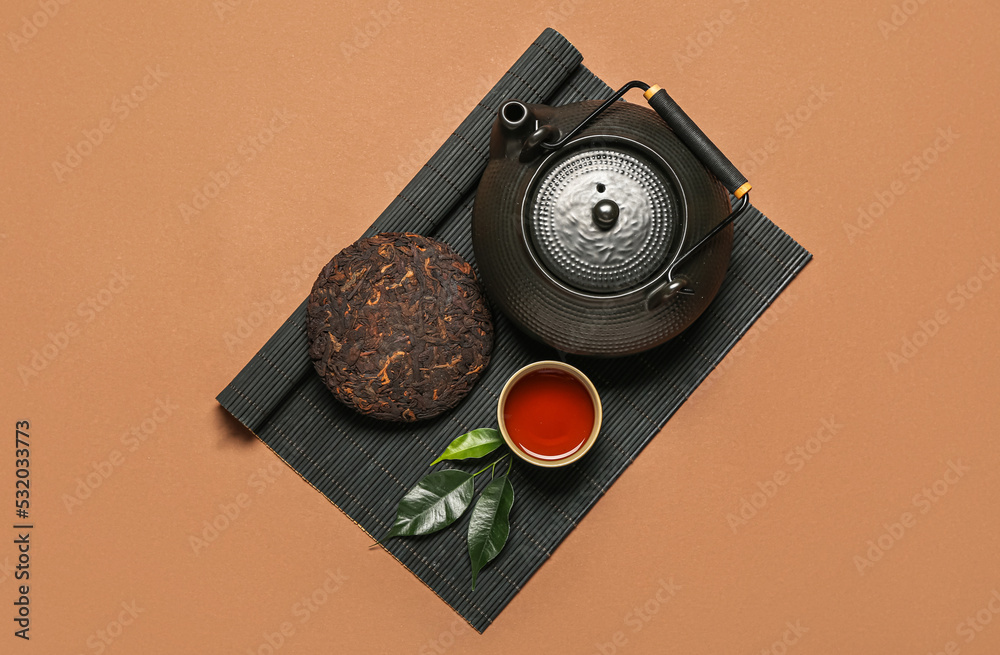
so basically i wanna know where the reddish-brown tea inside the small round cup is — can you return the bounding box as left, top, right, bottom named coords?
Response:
left=502, top=368, right=595, bottom=461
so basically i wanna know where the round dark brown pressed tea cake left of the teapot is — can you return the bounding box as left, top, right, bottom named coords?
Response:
left=307, top=233, right=493, bottom=421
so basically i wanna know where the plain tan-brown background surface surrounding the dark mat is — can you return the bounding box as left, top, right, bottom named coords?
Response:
left=0, top=0, right=1000, bottom=654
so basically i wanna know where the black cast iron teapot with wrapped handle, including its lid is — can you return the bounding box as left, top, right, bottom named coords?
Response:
left=472, top=81, right=750, bottom=356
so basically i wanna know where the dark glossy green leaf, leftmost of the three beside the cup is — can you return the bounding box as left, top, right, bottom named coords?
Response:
left=383, top=469, right=475, bottom=541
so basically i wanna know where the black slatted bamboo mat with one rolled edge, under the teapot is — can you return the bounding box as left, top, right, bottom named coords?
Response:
left=218, top=29, right=811, bottom=631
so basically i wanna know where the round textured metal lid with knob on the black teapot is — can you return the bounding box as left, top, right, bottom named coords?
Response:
left=525, top=146, right=679, bottom=293
